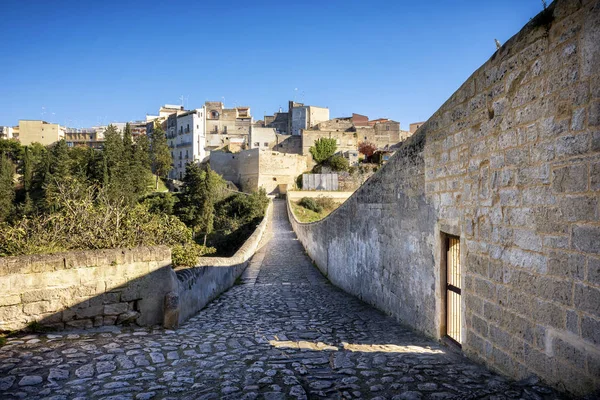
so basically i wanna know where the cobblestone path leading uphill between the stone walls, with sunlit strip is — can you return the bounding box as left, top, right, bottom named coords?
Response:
left=0, top=201, right=558, bottom=400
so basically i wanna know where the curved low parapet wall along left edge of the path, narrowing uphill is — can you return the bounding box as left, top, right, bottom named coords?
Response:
left=165, top=203, right=273, bottom=327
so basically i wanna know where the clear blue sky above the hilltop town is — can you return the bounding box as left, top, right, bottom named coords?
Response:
left=0, top=0, right=542, bottom=128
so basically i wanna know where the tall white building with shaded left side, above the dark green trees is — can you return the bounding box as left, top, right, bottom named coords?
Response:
left=167, top=107, right=207, bottom=180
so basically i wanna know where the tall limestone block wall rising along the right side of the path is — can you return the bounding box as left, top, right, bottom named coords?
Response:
left=291, top=0, right=600, bottom=394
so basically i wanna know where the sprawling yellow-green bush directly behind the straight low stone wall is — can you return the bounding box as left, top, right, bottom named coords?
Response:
left=0, top=180, right=197, bottom=256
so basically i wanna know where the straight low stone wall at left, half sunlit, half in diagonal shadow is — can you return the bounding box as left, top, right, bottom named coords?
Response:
left=0, top=246, right=177, bottom=331
